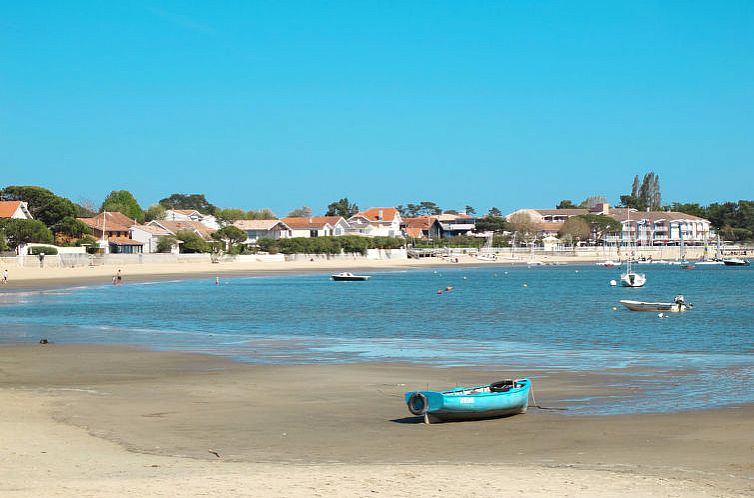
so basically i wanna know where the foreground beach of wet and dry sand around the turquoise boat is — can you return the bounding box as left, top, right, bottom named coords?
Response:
left=0, top=344, right=754, bottom=497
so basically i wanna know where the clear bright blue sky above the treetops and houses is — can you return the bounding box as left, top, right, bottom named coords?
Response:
left=0, top=0, right=754, bottom=214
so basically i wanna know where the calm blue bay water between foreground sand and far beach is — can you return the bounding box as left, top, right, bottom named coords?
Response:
left=0, top=265, right=754, bottom=414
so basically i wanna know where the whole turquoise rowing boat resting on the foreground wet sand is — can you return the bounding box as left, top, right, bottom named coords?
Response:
left=405, top=379, right=531, bottom=424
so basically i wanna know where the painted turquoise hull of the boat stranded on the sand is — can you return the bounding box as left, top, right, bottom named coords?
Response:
left=405, top=379, right=531, bottom=421
